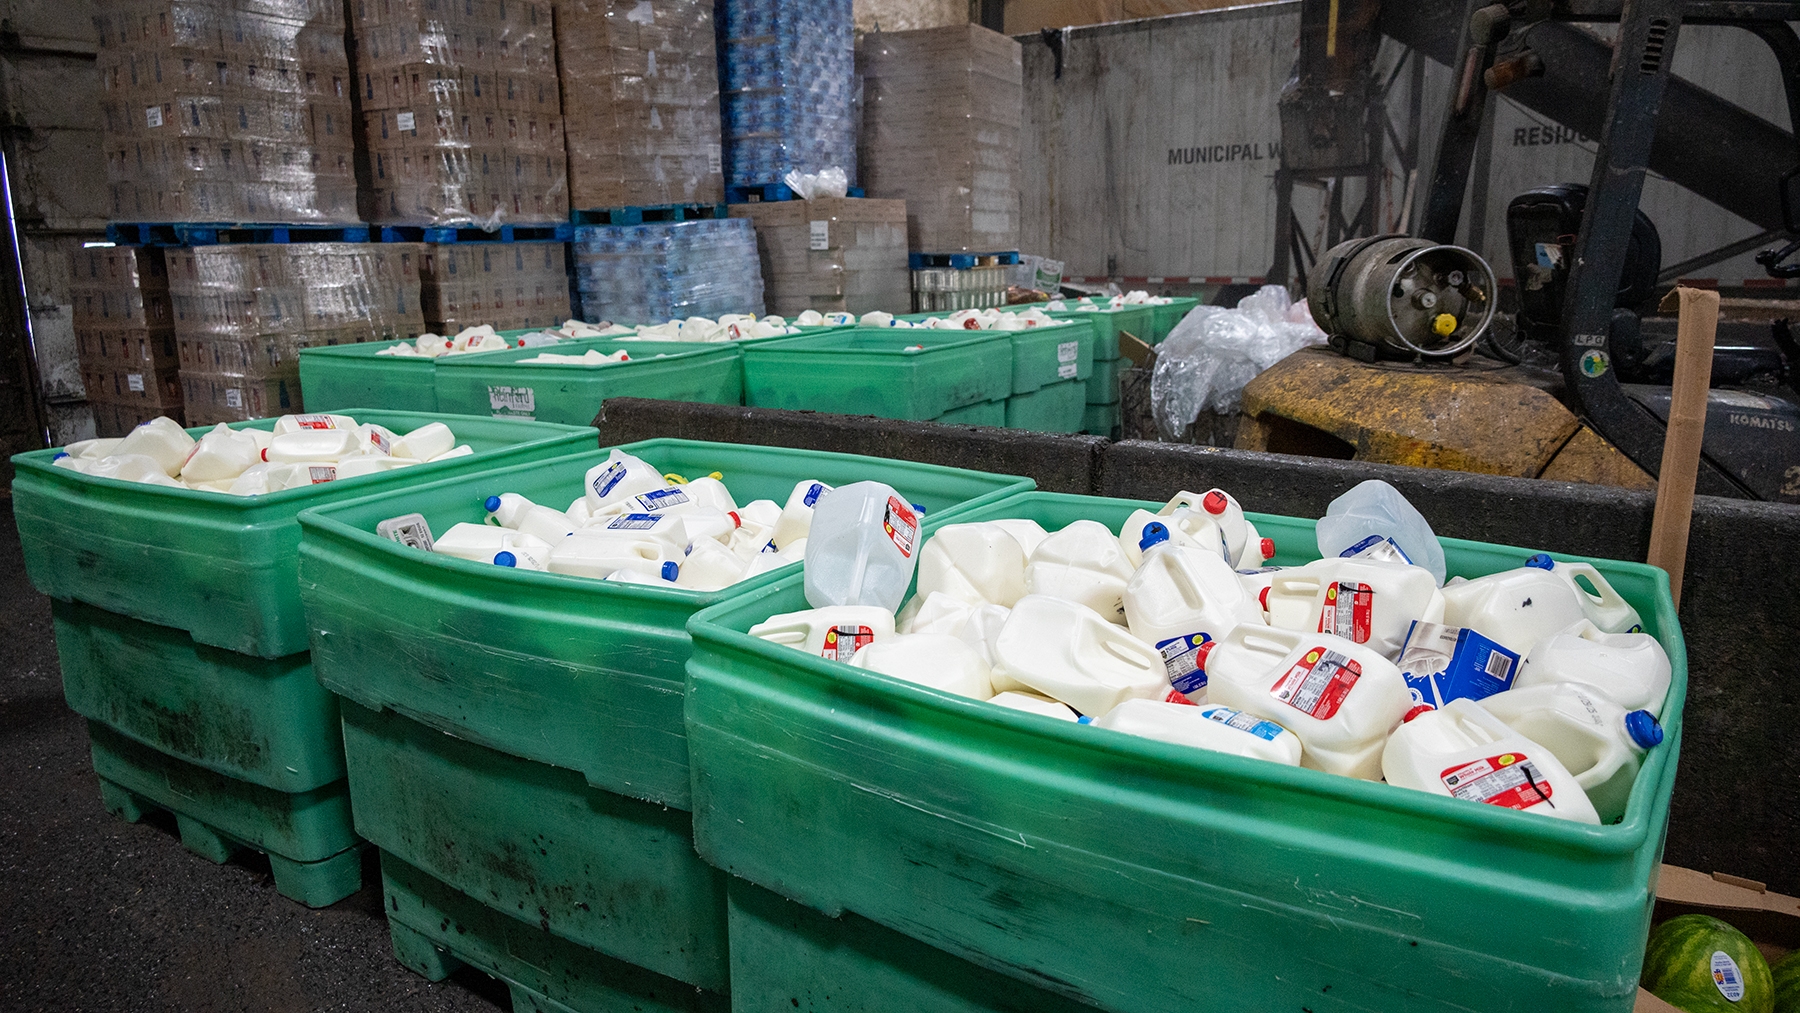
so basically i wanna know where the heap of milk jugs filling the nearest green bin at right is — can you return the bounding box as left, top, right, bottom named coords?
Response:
left=751, top=482, right=1670, bottom=824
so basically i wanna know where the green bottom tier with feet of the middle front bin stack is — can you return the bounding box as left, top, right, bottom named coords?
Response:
left=382, top=853, right=731, bottom=1013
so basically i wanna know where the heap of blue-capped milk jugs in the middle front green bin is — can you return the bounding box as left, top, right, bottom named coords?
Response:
left=430, top=450, right=832, bottom=592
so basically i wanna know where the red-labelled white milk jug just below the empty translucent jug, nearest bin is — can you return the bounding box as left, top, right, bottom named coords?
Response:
left=1264, top=558, right=1444, bottom=659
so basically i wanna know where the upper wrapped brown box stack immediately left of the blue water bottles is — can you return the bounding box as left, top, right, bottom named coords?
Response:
left=556, top=0, right=725, bottom=209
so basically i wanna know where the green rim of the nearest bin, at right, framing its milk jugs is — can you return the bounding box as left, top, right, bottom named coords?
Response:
left=688, top=489, right=1687, bottom=855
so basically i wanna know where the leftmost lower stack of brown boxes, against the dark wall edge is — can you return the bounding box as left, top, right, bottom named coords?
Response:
left=70, top=247, right=182, bottom=435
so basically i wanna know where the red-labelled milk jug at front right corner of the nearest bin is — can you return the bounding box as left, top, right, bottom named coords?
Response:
left=1381, top=693, right=1600, bottom=824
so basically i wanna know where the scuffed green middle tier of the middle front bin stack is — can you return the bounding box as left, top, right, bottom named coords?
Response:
left=344, top=704, right=729, bottom=991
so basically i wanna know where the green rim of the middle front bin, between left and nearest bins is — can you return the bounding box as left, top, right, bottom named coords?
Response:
left=299, top=437, right=1035, bottom=608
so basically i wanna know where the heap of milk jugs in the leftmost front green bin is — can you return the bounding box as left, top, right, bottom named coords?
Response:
left=52, top=416, right=475, bottom=497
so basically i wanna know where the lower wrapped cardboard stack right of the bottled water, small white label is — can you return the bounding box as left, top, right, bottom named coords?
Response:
left=731, top=198, right=911, bottom=317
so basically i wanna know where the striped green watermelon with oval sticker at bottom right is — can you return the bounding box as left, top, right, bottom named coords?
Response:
left=1638, top=914, right=1775, bottom=1013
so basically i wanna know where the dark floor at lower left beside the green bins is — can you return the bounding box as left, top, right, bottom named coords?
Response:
left=0, top=507, right=511, bottom=1013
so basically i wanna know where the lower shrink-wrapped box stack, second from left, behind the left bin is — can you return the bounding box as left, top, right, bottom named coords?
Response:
left=169, top=243, right=425, bottom=425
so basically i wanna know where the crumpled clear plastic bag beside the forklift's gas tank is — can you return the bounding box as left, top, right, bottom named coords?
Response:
left=1150, top=284, right=1325, bottom=439
